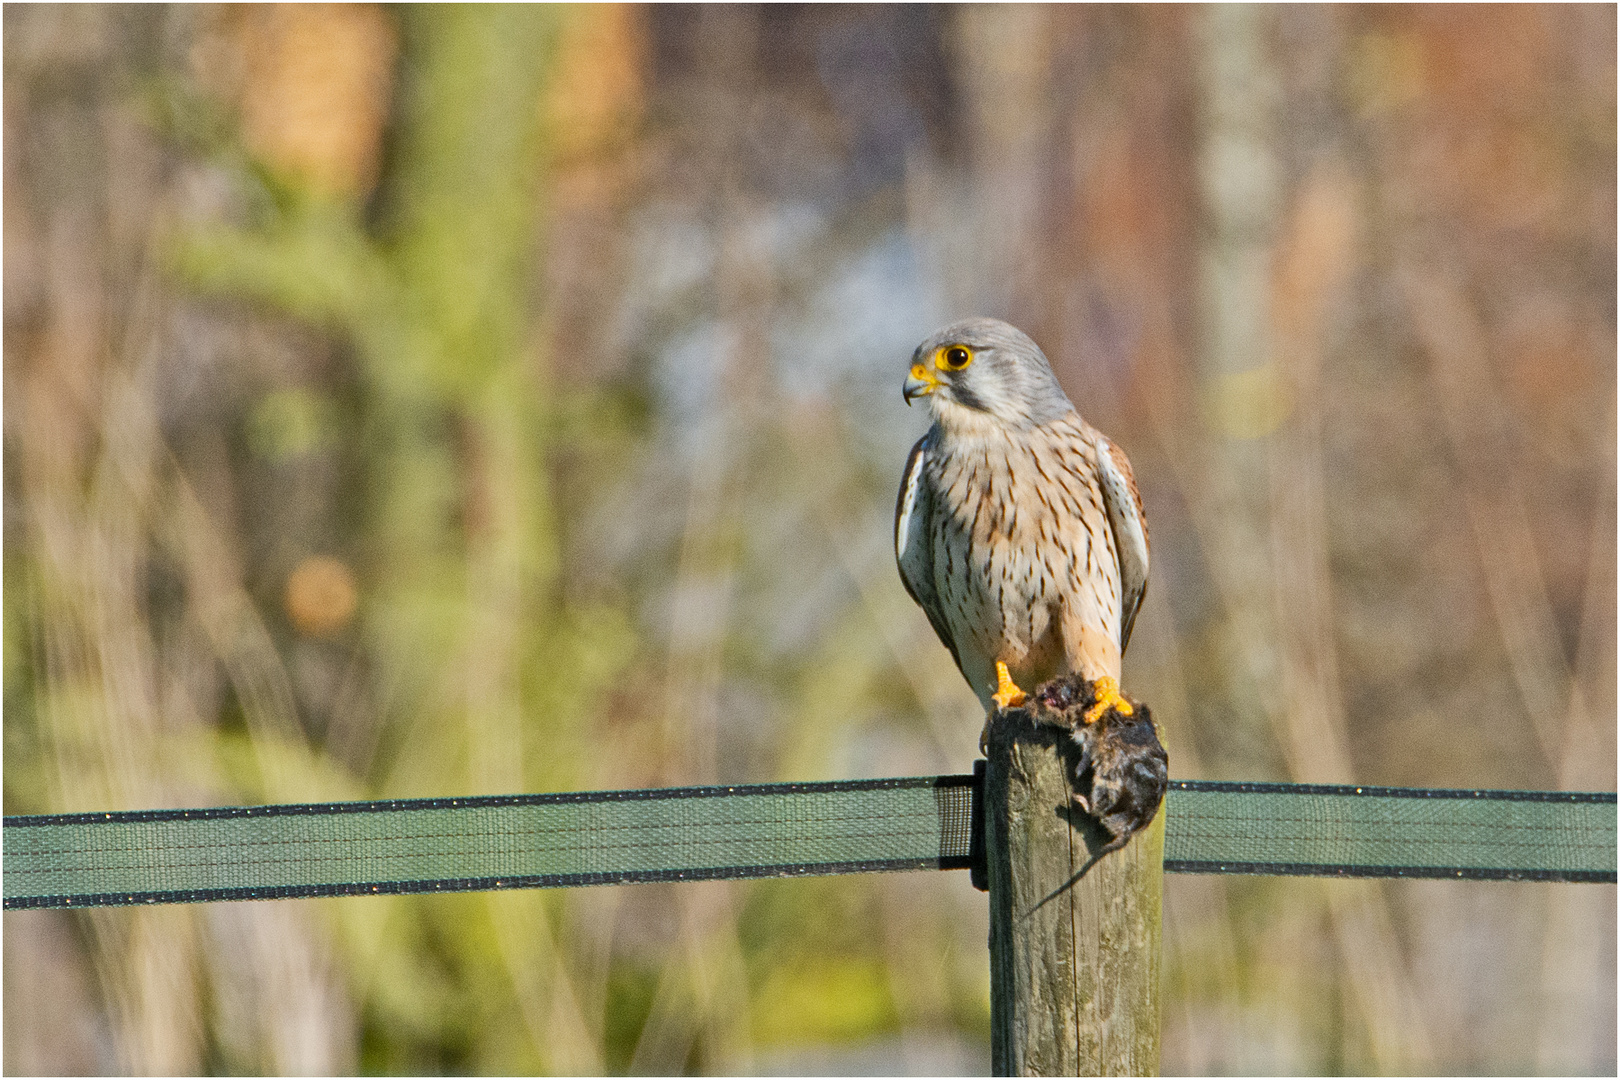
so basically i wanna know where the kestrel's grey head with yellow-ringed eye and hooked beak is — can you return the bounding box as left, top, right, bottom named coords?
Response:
left=906, top=319, right=1074, bottom=429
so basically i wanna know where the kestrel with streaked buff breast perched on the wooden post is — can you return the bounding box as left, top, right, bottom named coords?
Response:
left=894, top=319, right=1149, bottom=722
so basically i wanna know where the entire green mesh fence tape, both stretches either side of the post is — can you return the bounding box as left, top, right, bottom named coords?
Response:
left=3, top=776, right=1615, bottom=908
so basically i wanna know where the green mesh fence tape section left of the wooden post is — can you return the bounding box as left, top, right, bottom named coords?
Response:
left=3, top=776, right=974, bottom=908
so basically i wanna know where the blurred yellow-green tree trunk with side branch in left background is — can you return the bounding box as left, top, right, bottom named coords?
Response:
left=152, top=6, right=651, bottom=1072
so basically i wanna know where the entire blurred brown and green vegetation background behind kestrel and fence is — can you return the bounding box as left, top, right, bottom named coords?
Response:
left=3, top=5, right=1617, bottom=1075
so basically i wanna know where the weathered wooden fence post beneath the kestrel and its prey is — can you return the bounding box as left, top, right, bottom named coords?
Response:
left=983, top=709, right=1165, bottom=1077
